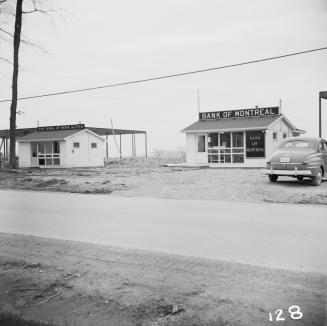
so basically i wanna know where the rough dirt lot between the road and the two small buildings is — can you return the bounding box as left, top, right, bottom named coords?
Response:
left=0, top=158, right=327, bottom=205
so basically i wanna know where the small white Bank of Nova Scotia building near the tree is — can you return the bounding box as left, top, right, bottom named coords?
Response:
left=17, top=125, right=105, bottom=168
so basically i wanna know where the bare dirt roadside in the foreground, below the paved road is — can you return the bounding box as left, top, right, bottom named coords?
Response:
left=0, top=233, right=327, bottom=326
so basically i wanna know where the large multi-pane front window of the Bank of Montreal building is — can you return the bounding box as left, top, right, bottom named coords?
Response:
left=208, top=131, right=245, bottom=163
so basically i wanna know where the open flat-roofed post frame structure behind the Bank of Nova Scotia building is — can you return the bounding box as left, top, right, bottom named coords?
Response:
left=0, top=126, right=148, bottom=164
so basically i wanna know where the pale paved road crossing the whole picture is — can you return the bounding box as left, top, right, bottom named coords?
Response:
left=0, top=191, right=327, bottom=273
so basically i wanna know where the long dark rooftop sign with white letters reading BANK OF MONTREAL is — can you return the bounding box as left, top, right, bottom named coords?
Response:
left=199, top=106, right=279, bottom=120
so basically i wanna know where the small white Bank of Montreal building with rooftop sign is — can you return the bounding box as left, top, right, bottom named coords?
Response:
left=181, top=107, right=305, bottom=168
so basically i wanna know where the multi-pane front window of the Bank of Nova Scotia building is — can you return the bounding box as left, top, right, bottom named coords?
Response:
left=31, top=141, right=60, bottom=166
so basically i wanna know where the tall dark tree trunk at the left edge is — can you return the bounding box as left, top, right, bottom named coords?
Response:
left=9, top=0, right=23, bottom=169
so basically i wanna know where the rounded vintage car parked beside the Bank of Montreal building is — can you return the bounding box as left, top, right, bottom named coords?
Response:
left=264, top=137, right=327, bottom=186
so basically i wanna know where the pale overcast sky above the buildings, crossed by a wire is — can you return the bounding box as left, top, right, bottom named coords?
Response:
left=0, top=0, right=327, bottom=155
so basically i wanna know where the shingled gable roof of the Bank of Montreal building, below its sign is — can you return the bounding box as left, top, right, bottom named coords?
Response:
left=182, top=115, right=304, bottom=133
